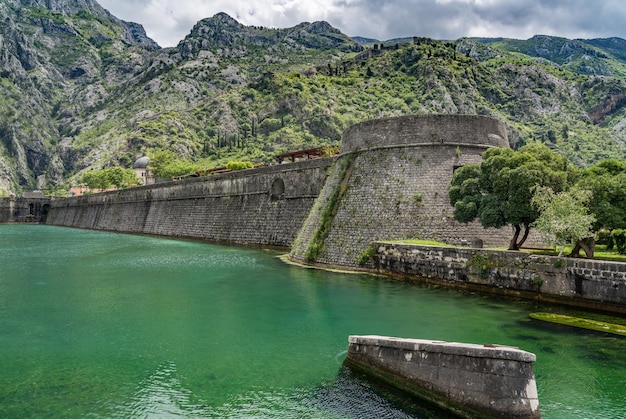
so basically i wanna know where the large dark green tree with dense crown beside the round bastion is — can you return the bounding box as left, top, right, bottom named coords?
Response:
left=448, top=144, right=570, bottom=250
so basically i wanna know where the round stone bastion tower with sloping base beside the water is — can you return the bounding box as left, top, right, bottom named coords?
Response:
left=290, top=115, right=510, bottom=266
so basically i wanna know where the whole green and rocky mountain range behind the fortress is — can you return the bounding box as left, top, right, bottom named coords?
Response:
left=0, top=0, right=626, bottom=194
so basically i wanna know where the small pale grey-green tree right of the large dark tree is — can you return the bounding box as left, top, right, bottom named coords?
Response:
left=532, top=186, right=596, bottom=258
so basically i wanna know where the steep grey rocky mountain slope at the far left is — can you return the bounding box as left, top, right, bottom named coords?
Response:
left=0, top=0, right=159, bottom=190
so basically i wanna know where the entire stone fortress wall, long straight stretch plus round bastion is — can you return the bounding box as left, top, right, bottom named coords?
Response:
left=46, top=115, right=508, bottom=260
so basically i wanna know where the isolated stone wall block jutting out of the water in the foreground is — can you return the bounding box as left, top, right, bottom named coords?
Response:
left=345, top=336, right=540, bottom=418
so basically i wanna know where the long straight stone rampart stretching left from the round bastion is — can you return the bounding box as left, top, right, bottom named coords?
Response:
left=47, top=159, right=333, bottom=247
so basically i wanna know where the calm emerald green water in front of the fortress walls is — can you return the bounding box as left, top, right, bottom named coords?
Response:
left=0, top=225, right=626, bottom=418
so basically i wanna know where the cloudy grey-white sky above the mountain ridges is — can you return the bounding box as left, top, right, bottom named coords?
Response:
left=98, top=0, right=626, bottom=47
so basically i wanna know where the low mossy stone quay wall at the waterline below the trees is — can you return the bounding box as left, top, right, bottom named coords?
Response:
left=374, top=242, right=626, bottom=313
